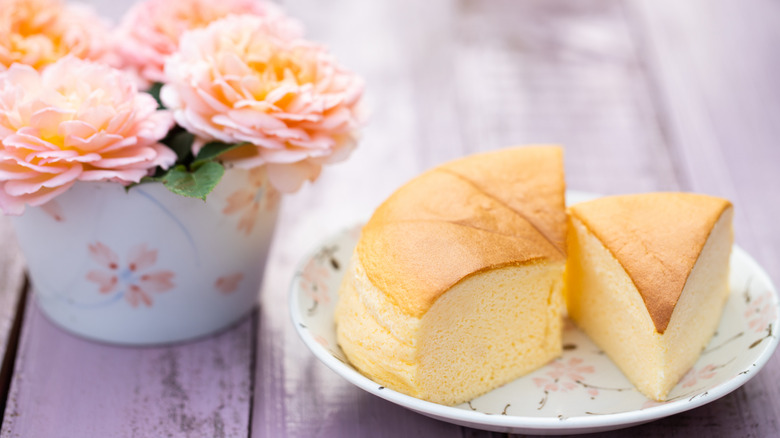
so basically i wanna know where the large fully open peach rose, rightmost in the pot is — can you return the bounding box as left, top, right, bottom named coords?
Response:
left=161, top=16, right=363, bottom=192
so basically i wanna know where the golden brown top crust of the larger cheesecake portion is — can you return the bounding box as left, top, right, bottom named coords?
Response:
left=357, top=146, right=566, bottom=316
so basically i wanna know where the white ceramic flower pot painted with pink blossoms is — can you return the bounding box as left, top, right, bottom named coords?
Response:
left=13, top=169, right=279, bottom=345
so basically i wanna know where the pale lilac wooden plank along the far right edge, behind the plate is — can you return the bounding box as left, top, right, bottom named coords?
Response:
left=616, top=0, right=780, bottom=437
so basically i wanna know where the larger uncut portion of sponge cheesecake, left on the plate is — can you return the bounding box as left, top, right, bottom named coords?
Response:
left=335, top=147, right=566, bottom=405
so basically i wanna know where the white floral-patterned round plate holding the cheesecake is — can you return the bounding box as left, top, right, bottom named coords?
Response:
left=290, top=193, right=780, bottom=434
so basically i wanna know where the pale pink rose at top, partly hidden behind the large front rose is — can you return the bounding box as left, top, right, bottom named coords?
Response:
left=117, top=0, right=302, bottom=86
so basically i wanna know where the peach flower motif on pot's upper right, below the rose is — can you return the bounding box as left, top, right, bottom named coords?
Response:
left=222, top=167, right=280, bottom=236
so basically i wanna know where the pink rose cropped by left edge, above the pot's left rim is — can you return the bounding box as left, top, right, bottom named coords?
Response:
left=0, top=56, right=176, bottom=214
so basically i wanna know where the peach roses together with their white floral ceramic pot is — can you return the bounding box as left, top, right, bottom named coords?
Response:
left=0, top=0, right=364, bottom=344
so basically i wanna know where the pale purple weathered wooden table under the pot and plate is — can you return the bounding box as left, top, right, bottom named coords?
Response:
left=0, top=0, right=780, bottom=438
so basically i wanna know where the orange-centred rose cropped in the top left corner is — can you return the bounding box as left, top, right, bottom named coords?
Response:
left=0, top=0, right=110, bottom=71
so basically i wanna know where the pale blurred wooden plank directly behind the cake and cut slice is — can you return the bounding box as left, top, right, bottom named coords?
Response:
left=448, top=0, right=679, bottom=194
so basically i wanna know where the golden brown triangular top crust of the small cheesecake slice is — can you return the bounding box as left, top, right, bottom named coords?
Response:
left=569, top=193, right=731, bottom=333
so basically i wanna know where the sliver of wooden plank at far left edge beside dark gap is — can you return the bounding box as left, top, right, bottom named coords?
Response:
left=0, top=213, right=25, bottom=415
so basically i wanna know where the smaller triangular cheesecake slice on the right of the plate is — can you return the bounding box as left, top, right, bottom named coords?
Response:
left=566, top=193, right=733, bottom=401
